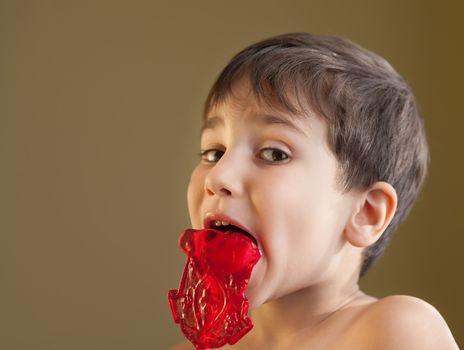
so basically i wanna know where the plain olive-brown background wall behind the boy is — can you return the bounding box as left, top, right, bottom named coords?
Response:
left=0, top=0, right=464, bottom=350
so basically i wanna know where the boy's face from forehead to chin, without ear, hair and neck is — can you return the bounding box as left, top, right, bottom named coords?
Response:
left=188, top=83, right=354, bottom=307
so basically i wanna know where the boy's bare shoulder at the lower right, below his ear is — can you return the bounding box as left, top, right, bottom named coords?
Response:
left=358, top=295, right=459, bottom=350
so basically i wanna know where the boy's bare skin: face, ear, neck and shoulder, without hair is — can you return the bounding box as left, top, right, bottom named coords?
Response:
left=174, top=80, right=458, bottom=350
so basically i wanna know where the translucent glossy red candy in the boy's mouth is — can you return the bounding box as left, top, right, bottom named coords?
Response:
left=168, top=229, right=261, bottom=350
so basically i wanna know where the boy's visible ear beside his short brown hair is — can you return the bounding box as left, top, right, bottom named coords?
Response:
left=345, top=181, right=398, bottom=248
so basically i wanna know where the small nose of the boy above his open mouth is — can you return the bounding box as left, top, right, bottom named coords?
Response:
left=205, top=152, right=244, bottom=197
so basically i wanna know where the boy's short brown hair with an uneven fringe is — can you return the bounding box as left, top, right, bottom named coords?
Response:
left=205, top=33, right=428, bottom=276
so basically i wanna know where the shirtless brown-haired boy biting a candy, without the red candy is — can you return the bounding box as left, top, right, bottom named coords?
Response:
left=169, top=33, right=458, bottom=350
